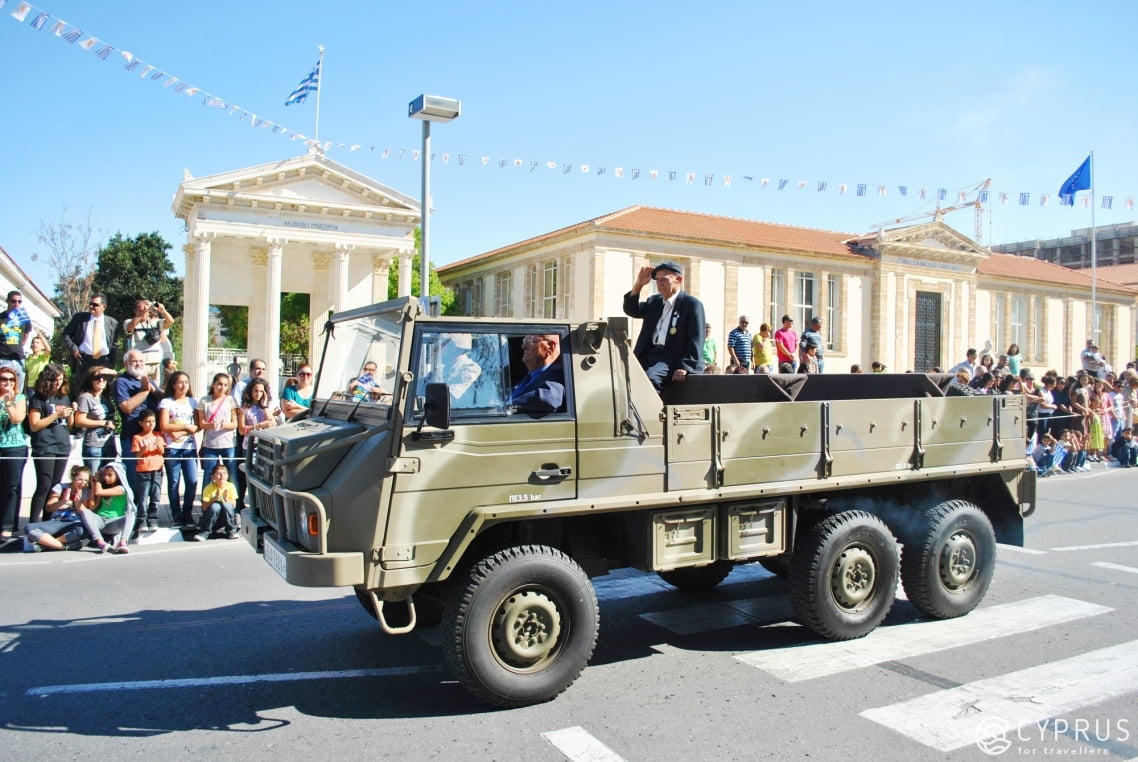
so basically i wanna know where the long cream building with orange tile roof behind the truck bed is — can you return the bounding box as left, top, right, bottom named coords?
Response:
left=438, top=206, right=1138, bottom=373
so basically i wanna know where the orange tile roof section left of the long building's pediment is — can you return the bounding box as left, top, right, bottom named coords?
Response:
left=439, top=206, right=863, bottom=272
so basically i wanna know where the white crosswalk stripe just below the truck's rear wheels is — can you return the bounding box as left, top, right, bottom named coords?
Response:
left=735, top=595, right=1114, bottom=682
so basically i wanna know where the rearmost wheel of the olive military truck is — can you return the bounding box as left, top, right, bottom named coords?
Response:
left=901, top=500, right=996, bottom=619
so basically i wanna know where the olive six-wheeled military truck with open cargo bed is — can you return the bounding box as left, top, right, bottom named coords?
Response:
left=241, top=299, right=1034, bottom=706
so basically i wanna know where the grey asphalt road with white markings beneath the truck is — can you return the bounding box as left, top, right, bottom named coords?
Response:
left=0, top=470, right=1138, bottom=761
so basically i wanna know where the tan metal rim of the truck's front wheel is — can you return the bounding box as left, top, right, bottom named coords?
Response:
left=490, top=589, right=562, bottom=671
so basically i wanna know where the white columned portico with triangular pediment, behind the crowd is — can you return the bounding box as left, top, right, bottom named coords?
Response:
left=173, top=151, right=420, bottom=398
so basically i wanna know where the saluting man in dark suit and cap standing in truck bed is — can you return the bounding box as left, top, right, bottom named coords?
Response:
left=624, top=262, right=706, bottom=391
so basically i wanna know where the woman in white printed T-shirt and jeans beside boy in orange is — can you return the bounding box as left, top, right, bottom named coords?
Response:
left=158, top=371, right=198, bottom=528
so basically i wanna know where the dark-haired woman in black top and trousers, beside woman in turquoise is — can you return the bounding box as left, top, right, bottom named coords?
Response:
left=27, top=363, right=75, bottom=523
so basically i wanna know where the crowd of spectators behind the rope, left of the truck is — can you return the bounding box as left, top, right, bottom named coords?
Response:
left=0, top=291, right=293, bottom=554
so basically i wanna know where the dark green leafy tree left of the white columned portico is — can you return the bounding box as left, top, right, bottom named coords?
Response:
left=91, top=232, right=182, bottom=359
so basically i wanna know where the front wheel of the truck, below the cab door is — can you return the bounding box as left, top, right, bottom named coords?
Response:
left=443, top=545, right=601, bottom=707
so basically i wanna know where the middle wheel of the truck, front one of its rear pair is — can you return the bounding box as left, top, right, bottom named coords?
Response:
left=790, top=511, right=898, bottom=640
